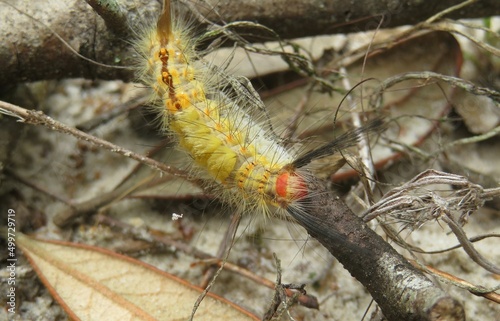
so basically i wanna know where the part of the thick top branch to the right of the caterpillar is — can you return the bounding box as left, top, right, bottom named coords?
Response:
left=196, top=0, right=500, bottom=38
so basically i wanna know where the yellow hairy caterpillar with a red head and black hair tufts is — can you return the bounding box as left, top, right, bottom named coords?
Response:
left=137, top=1, right=379, bottom=215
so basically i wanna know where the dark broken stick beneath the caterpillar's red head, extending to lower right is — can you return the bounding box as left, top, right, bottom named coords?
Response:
left=289, top=176, right=465, bottom=321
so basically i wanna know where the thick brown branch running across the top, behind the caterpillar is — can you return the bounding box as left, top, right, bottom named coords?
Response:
left=0, top=0, right=500, bottom=87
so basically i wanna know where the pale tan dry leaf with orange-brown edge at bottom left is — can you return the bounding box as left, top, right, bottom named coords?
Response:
left=18, top=234, right=258, bottom=321
